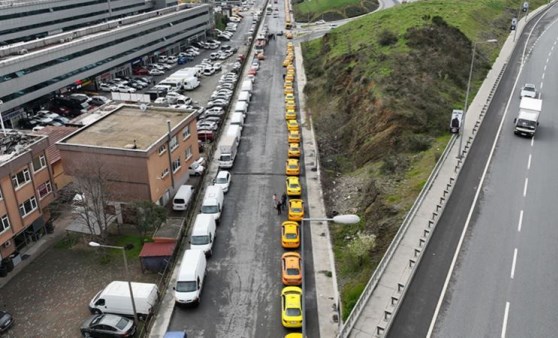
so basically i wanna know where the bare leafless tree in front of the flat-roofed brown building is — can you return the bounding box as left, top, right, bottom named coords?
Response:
left=73, top=158, right=115, bottom=240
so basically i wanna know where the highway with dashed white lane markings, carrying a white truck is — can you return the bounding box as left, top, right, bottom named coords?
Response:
left=388, top=6, right=558, bottom=337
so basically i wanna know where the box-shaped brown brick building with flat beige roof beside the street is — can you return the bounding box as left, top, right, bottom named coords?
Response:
left=56, top=105, right=199, bottom=210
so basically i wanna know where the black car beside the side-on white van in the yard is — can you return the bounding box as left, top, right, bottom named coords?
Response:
left=81, top=314, right=136, bottom=337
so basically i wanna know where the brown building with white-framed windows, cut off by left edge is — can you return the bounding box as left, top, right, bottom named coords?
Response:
left=0, top=131, right=55, bottom=258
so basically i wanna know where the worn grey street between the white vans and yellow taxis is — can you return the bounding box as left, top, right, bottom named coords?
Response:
left=169, top=6, right=319, bottom=337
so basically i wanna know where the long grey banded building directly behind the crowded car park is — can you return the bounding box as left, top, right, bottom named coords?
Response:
left=0, top=0, right=211, bottom=127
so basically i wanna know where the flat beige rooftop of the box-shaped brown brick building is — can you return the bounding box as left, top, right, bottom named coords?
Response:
left=63, top=105, right=192, bottom=150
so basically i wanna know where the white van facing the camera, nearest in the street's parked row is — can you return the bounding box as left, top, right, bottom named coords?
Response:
left=173, top=249, right=207, bottom=305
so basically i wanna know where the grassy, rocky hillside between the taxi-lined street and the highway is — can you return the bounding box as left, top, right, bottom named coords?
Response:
left=303, top=0, right=546, bottom=317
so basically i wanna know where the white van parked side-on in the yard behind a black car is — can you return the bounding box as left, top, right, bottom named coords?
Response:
left=89, top=281, right=159, bottom=319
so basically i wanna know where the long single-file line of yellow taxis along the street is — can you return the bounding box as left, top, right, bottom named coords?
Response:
left=281, top=41, right=304, bottom=338
